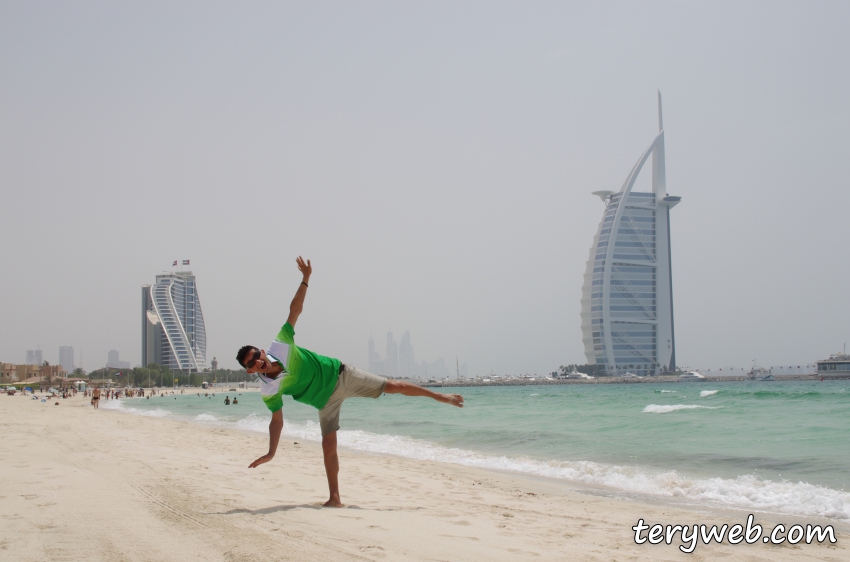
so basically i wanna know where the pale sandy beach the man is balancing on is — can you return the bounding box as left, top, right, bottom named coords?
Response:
left=0, top=395, right=850, bottom=562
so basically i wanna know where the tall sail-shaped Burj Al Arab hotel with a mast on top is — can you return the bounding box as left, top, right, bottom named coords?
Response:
left=581, top=92, right=681, bottom=376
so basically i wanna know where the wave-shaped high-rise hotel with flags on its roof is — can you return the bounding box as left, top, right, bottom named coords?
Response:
left=142, top=271, right=207, bottom=372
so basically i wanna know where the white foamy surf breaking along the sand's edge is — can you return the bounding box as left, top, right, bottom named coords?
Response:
left=103, top=392, right=850, bottom=524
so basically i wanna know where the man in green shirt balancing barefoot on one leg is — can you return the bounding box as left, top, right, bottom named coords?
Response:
left=236, top=256, right=463, bottom=507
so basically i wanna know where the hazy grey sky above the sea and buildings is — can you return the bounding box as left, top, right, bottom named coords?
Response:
left=0, top=1, right=850, bottom=375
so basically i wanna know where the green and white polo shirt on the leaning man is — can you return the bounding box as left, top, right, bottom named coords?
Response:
left=258, top=322, right=340, bottom=412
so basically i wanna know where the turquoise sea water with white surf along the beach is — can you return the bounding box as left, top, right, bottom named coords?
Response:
left=101, top=381, right=850, bottom=520
